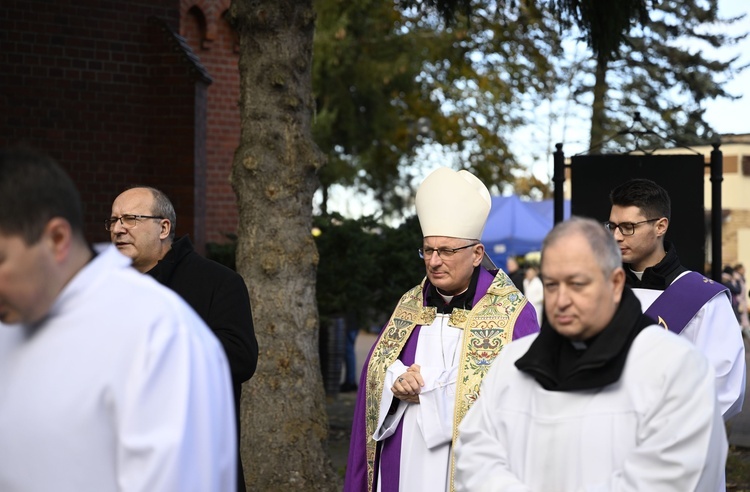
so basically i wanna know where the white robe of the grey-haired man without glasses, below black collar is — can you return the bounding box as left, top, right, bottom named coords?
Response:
left=456, top=325, right=727, bottom=492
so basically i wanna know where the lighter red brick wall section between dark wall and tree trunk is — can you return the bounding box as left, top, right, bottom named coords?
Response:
left=180, top=0, right=240, bottom=243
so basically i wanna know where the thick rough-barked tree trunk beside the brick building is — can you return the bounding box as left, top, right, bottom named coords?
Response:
left=230, top=0, right=340, bottom=491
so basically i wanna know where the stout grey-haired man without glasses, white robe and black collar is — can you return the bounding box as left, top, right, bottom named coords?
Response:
left=456, top=218, right=727, bottom=492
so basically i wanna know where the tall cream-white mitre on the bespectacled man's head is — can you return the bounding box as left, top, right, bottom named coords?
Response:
left=416, top=167, right=492, bottom=240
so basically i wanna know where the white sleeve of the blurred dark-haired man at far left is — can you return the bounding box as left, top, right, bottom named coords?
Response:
left=116, top=308, right=237, bottom=492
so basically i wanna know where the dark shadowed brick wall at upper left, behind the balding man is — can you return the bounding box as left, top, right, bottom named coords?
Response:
left=0, top=0, right=205, bottom=244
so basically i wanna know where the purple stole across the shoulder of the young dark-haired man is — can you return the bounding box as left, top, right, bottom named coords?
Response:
left=643, top=272, right=727, bottom=335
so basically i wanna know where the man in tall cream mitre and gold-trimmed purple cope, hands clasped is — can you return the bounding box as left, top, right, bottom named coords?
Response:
left=344, top=168, right=539, bottom=492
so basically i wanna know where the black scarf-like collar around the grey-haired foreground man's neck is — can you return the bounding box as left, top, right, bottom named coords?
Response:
left=516, top=287, right=654, bottom=391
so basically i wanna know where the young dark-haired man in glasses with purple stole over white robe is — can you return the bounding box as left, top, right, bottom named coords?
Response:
left=605, top=178, right=746, bottom=421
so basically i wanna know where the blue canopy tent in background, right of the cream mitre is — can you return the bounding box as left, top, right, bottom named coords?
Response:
left=482, top=195, right=570, bottom=268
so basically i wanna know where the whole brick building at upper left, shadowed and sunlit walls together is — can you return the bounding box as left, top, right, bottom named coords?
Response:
left=0, top=0, right=240, bottom=251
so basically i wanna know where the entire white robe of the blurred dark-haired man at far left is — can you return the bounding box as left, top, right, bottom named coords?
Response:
left=0, top=246, right=237, bottom=492
